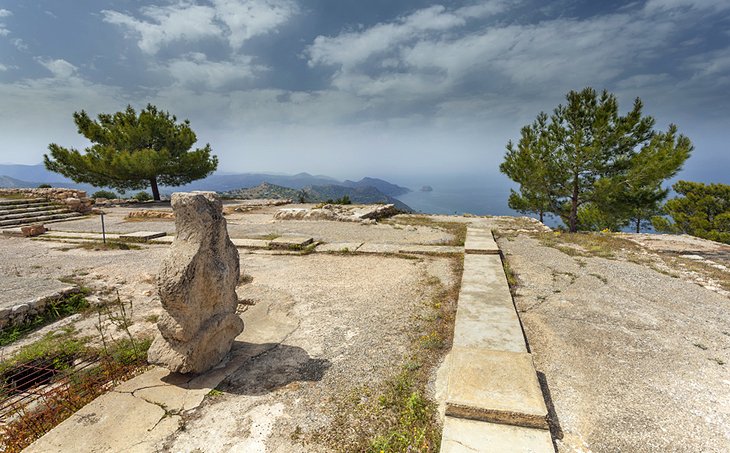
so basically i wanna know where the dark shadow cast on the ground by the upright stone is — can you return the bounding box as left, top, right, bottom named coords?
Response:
left=210, top=341, right=331, bottom=395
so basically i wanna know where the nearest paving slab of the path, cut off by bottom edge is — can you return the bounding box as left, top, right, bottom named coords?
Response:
left=441, top=417, right=555, bottom=453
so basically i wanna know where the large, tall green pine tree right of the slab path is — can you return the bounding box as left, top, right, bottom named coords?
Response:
left=500, top=88, right=692, bottom=232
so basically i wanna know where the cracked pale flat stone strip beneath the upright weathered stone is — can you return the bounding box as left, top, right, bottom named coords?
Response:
left=24, top=296, right=299, bottom=453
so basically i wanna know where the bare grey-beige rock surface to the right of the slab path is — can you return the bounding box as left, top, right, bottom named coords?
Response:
left=499, top=234, right=730, bottom=452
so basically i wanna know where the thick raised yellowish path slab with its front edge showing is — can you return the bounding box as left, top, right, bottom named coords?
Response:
left=446, top=347, right=548, bottom=429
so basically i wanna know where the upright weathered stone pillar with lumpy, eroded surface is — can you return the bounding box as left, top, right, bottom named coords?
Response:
left=148, top=192, right=243, bottom=373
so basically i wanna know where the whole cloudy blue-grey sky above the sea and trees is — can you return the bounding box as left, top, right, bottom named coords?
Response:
left=0, top=0, right=730, bottom=183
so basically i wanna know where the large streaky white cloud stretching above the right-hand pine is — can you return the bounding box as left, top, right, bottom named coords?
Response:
left=307, top=0, right=704, bottom=102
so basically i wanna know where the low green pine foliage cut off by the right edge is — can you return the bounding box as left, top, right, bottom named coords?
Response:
left=652, top=181, right=730, bottom=244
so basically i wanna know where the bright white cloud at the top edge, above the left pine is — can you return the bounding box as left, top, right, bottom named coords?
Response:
left=102, top=0, right=298, bottom=54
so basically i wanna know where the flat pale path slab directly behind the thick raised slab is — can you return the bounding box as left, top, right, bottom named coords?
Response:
left=454, top=292, right=527, bottom=352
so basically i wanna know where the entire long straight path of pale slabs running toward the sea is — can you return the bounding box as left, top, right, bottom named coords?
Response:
left=441, top=226, right=554, bottom=453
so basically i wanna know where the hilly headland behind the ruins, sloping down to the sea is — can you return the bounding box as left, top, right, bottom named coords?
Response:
left=221, top=183, right=413, bottom=212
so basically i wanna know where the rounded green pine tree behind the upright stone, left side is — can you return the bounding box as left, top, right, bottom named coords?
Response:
left=43, top=104, right=218, bottom=200
